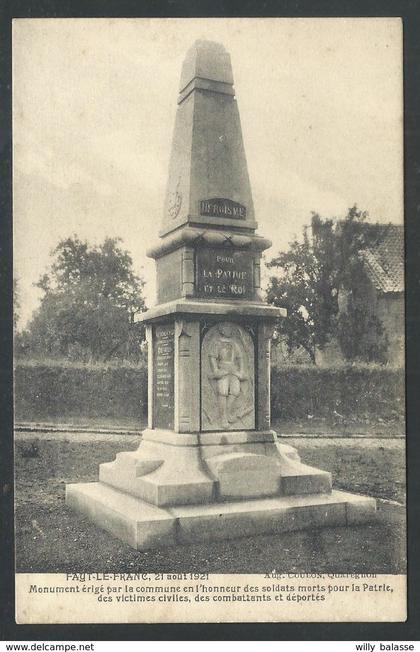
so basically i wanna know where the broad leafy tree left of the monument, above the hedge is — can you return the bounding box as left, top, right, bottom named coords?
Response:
left=23, top=236, right=145, bottom=361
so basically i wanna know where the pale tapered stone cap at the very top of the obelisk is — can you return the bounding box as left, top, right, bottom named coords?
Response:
left=179, top=40, right=233, bottom=92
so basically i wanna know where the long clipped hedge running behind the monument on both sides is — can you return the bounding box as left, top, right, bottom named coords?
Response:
left=15, top=362, right=405, bottom=421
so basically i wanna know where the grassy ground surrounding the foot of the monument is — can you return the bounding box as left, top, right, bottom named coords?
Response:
left=15, top=433, right=405, bottom=573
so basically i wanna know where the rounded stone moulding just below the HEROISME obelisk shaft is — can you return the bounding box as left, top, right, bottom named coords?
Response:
left=146, top=226, right=272, bottom=259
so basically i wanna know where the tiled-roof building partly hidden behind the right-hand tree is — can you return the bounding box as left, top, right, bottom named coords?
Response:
left=316, top=224, right=405, bottom=366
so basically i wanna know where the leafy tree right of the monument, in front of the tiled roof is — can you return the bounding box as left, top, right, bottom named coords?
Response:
left=267, top=206, right=386, bottom=362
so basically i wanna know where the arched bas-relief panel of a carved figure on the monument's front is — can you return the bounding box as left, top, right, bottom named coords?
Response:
left=201, top=322, right=255, bottom=431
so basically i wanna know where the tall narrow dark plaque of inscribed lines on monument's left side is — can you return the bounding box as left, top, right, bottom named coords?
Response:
left=153, top=325, right=174, bottom=430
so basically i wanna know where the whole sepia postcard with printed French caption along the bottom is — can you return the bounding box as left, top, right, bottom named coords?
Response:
left=13, top=18, right=407, bottom=624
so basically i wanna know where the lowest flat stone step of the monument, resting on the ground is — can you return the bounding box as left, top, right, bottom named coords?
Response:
left=66, top=482, right=376, bottom=550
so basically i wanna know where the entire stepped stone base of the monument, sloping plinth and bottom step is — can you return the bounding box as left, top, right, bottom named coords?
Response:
left=66, top=429, right=376, bottom=550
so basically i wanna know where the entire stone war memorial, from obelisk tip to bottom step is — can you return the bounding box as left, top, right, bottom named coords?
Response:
left=66, top=41, right=376, bottom=549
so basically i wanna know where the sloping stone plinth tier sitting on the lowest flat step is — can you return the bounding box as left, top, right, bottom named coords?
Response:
left=95, top=429, right=331, bottom=507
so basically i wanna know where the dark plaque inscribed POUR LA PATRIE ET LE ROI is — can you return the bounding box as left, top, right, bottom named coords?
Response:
left=196, top=247, right=254, bottom=299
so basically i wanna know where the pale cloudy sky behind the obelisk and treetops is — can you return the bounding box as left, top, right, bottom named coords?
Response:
left=13, top=18, right=403, bottom=327
